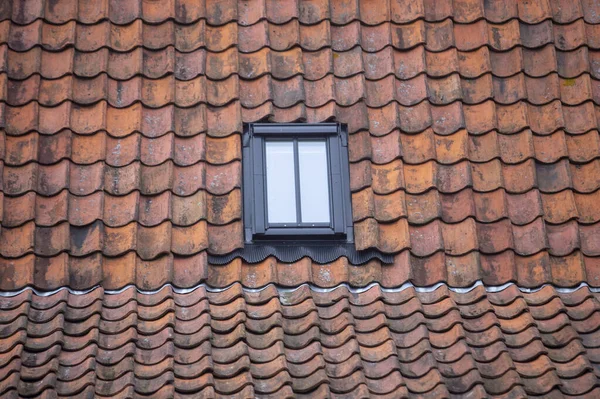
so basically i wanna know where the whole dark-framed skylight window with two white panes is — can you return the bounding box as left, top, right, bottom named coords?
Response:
left=243, top=123, right=352, bottom=242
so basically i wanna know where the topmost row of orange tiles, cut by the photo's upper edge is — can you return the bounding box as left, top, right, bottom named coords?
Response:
left=0, top=0, right=600, bottom=26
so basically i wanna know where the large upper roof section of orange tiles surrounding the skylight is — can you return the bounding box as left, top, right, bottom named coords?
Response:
left=0, top=0, right=600, bottom=290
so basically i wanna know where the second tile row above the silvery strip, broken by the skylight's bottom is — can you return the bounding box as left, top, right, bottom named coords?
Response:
left=0, top=216, right=600, bottom=260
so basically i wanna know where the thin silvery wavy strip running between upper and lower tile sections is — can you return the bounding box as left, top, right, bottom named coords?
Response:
left=0, top=280, right=600, bottom=297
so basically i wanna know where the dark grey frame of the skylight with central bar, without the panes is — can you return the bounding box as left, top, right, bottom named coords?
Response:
left=242, top=123, right=354, bottom=243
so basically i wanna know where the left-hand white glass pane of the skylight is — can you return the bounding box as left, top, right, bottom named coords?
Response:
left=265, top=141, right=296, bottom=223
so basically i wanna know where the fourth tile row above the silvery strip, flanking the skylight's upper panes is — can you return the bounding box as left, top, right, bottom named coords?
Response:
left=0, top=159, right=600, bottom=196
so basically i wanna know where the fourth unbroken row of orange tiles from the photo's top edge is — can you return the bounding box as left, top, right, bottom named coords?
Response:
left=5, top=73, right=600, bottom=109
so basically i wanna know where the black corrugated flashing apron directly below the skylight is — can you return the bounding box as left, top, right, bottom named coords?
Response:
left=208, top=242, right=394, bottom=265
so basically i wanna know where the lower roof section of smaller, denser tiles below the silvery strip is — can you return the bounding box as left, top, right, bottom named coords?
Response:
left=0, top=284, right=600, bottom=398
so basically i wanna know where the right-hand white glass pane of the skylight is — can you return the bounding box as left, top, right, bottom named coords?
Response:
left=298, top=140, right=329, bottom=223
